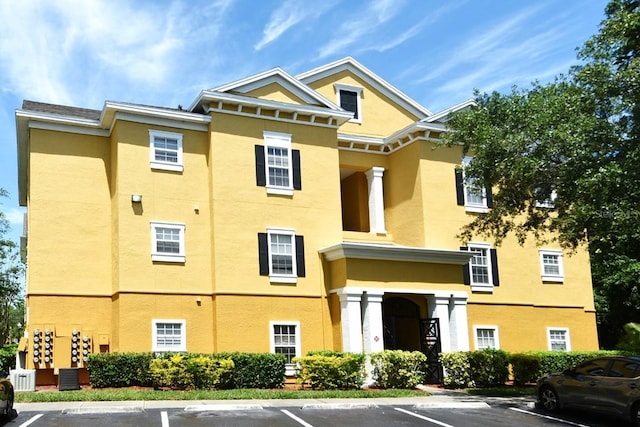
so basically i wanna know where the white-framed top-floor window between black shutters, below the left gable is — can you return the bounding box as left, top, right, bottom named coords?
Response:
left=263, top=131, right=293, bottom=196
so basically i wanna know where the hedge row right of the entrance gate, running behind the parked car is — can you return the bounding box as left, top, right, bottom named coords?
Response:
left=440, top=349, right=626, bottom=388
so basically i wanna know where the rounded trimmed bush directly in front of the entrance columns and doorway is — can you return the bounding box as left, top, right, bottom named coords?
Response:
left=371, top=350, right=427, bottom=389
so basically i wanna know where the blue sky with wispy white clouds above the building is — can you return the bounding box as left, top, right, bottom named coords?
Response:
left=0, top=0, right=607, bottom=244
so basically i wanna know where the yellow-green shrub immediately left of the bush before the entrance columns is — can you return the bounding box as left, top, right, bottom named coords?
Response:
left=293, top=353, right=365, bottom=390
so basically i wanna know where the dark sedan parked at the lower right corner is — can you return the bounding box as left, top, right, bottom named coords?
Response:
left=536, top=356, right=640, bottom=426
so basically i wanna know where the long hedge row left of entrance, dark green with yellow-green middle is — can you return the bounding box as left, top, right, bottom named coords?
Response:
left=87, top=353, right=285, bottom=389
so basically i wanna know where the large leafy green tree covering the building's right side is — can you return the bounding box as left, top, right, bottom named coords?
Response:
left=446, top=0, right=640, bottom=348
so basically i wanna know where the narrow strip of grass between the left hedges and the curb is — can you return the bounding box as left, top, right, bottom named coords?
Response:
left=16, top=388, right=429, bottom=402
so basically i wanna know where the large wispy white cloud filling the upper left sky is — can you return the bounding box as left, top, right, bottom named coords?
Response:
left=0, top=0, right=233, bottom=108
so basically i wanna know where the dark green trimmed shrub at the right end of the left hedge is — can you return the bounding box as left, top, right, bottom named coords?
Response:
left=214, top=352, right=286, bottom=388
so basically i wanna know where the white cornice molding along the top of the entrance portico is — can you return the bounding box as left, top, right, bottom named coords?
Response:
left=318, top=242, right=473, bottom=265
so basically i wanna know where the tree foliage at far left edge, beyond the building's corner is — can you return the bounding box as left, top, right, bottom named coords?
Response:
left=0, top=188, right=23, bottom=347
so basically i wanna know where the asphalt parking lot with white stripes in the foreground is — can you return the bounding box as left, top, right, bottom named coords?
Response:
left=0, top=396, right=625, bottom=427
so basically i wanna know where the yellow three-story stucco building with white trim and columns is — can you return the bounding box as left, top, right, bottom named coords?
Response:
left=16, top=58, right=598, bottom=382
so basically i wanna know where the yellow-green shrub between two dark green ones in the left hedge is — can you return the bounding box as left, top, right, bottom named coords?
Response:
left=150, top=354, right=234, bottom=390
